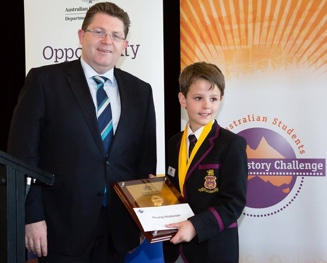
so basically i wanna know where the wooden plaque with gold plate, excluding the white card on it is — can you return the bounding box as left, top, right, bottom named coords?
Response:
left=113, top=177, right=186, bottom=243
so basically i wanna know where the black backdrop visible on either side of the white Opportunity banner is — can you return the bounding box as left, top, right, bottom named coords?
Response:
left=0, top=0, right=180, bottom=170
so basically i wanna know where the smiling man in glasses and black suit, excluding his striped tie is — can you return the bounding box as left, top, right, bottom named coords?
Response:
left=8, top=2, right=156, bottom=263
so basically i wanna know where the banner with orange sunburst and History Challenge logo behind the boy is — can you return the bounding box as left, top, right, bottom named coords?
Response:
left=180, top=0, right=327, bottom=263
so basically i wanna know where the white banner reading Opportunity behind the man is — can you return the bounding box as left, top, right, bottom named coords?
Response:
left=24, top=0, right=165, bottom=174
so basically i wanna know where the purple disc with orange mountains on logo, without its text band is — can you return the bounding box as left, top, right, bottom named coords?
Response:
left=239, top=128, right=296, bottom=208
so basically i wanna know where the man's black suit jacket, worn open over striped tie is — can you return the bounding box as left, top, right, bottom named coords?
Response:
left=8, top=60, right=156, bottom=255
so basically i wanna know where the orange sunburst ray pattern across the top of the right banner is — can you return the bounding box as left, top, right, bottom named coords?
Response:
left=180, top=0, right=327, bottom=76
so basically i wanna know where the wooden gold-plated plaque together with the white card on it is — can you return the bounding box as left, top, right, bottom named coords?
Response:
left=113, top=177, right=194, bottom=243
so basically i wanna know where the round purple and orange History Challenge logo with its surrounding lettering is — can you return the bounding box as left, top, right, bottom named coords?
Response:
left=226, top=114, right=326, bottom=217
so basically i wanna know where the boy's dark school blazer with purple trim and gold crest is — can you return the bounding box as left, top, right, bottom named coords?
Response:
left=164, top=121, right=248, bottom=263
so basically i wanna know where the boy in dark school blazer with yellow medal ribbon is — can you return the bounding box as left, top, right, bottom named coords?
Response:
left=164, top=62, right=248, bottom=263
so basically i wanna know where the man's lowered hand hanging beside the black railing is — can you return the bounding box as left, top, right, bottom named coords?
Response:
left=25, top=221, right=48, bottom=257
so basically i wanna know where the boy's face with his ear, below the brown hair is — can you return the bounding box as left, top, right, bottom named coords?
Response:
left=178, top=79, right=222, bottom=132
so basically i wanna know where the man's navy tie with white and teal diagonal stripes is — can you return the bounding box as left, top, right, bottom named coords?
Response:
left=93, top=76, right=113, bottom=207
